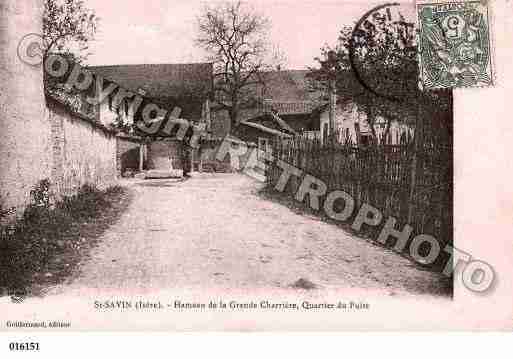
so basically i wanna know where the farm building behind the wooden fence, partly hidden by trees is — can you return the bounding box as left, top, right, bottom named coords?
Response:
left=216, top=70, right=413, bottom=150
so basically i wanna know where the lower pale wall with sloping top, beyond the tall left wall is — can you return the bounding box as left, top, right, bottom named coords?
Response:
left=47, top=98, right=117, bottom=199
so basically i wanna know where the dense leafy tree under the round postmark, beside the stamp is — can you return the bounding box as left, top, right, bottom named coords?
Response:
left=309, top=6, right=450, bottom=143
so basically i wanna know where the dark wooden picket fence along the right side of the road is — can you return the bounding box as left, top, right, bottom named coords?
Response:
left=267, top=136, right=452, bottom=256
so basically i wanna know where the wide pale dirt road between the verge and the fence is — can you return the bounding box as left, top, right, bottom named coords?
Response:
left=51, top=174, right=443, bottom=295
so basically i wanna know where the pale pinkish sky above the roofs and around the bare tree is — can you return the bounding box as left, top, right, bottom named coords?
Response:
left=84, top=0, right=413, bottom=69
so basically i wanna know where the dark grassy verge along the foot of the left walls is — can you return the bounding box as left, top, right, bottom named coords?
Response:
left=0, top=180, right=131, bottom=297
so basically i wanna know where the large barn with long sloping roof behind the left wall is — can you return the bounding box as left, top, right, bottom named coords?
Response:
left=89, top=63, right=213, bottom=176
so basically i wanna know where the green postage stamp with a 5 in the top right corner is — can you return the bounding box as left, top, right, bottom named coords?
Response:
left=417, top=1, right=493, bottom=90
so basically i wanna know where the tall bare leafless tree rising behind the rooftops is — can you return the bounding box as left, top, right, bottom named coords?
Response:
left=196, top=2, right=282, bottom=126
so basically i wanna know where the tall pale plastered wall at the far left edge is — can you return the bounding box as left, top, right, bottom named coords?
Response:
left=0, top=0, right=52, bottom=214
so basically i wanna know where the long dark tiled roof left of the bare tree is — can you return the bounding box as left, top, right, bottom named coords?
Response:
left=89, top=63, right=213, bottom=98
